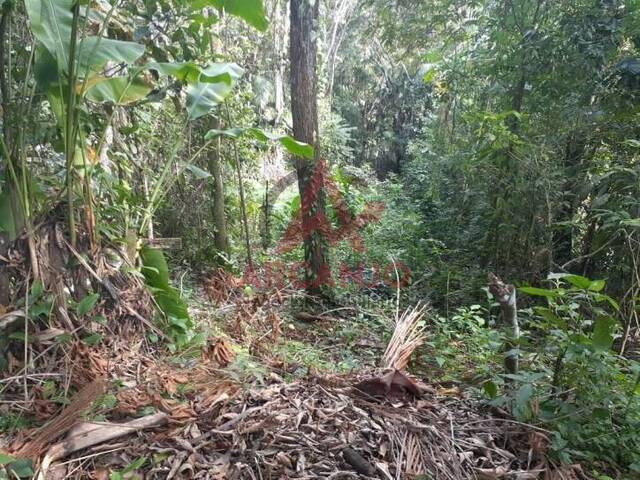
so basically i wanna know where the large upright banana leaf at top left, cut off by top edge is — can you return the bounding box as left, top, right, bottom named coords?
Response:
left=24, top=0, right=75, bottom=72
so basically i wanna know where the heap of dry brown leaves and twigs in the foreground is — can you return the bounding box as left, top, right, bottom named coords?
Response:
left=132, top=372, right=545, bottom=480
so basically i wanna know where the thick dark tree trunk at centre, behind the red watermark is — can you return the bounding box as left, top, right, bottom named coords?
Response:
left=289, top=0, right=329, bottom=293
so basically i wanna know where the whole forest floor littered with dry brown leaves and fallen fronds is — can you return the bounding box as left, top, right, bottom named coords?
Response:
left=0, top=274, right=587, bottom=480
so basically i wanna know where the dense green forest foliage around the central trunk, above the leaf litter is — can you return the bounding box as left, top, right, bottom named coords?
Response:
left=0, top=0, right=640, bottom=478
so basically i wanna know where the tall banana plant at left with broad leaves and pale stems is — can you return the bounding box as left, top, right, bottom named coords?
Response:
left=25, top=0, right=248, bottom=245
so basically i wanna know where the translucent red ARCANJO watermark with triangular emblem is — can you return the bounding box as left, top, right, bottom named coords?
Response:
left=243, top=160, right=411, bottom=289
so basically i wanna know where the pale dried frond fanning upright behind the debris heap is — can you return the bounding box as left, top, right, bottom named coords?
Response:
left=382, top=303, right=428, bottom=370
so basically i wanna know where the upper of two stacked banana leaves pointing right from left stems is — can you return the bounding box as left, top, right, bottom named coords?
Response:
left=78, top=37, right=144, bottom=75
